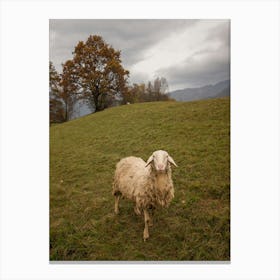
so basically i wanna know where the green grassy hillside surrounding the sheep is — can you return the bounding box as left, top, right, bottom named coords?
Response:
left=50, top=98, right=230, bottom=260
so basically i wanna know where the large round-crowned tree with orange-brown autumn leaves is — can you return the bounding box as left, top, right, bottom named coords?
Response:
left=73, top=35, right=129, bottom=111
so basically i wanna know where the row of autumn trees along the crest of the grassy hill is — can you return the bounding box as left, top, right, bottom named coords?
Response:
left=49, top=35, right=171, bottom=123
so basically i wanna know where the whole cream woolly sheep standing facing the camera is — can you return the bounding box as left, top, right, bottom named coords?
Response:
left=113, top=150, right=177, bottom=241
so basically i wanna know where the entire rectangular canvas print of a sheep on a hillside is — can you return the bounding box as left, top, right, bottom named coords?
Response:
left=49, top=19, right=230, bottom=262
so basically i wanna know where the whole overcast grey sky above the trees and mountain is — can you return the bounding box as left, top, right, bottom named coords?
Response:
left=49, top=19, right=230, bottom=91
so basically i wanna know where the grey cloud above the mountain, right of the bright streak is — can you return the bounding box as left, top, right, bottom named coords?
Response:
left=157, top=20, right=230, bottom=89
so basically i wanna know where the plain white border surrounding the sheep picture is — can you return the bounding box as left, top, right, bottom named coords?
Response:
left=0, top=0, right=280, bottom=280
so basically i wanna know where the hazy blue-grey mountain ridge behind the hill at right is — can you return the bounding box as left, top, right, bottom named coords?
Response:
left=169, top=80, right=230, bottom=101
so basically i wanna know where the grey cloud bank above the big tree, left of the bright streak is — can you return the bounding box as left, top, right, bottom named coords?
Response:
left=50, top=19, right=197, bottom=70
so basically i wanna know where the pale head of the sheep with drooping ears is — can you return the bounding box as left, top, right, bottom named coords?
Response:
left=146, top=150, right=177, bottom=173
